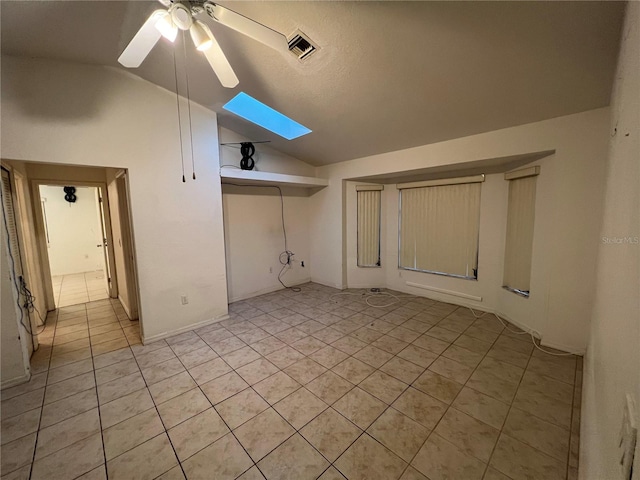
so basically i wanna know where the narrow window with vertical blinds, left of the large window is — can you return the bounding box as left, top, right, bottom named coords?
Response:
left=356, top=185, right=383, bottom=267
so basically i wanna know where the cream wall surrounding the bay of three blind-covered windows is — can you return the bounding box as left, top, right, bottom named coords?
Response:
left=310, top=108, right=609, bottom=352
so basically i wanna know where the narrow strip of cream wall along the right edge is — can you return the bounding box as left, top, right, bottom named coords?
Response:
left=579, top=2, right=640, bottom=480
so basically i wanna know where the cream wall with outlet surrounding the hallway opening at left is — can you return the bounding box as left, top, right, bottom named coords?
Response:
left=2, top=57, right=227, bottom=340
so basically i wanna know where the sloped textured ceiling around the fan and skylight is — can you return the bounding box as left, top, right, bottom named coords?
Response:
left=0, top=0, right=624, bottom=165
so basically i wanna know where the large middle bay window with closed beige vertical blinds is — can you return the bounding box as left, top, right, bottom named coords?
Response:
left=398, top=175, right=484, bottom=279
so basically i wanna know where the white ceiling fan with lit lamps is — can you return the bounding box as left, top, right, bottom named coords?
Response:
left=118, top=0, right=288, bottom=88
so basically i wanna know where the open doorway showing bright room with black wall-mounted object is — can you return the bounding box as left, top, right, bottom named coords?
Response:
left=39, top=185, right=111, bottom=308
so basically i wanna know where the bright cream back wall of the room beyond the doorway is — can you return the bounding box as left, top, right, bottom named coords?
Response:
left=40, top=185, right=105, bottom=275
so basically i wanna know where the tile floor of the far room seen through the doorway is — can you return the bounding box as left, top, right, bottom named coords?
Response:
left=51, top=270, right=109, bottom=308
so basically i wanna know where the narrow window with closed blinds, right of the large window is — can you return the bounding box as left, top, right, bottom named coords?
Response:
left=503, top=167, right=540, bottom=297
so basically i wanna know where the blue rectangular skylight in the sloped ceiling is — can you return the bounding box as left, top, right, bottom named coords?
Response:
left=222, top=92, right=311, bottom=140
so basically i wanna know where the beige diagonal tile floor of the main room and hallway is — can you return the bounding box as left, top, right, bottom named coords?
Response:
left=2, top=284, right=582, bottom=480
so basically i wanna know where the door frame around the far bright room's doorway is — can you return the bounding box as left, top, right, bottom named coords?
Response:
left=31, top=178, right=118, bottom=310
